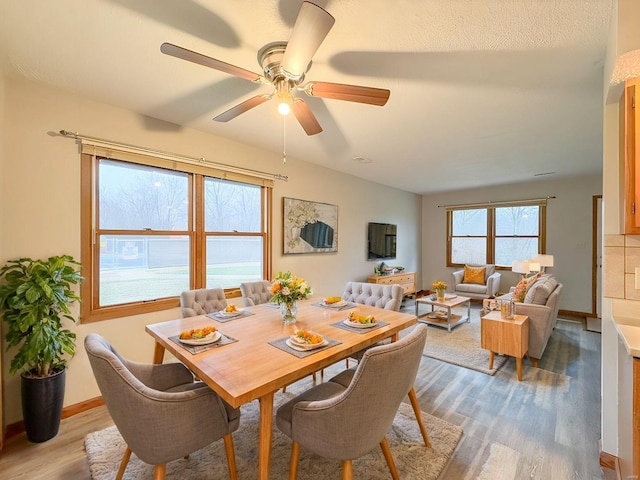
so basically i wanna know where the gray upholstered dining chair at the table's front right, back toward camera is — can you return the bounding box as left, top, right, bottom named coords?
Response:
left=276, top=324, right=427, bottom=480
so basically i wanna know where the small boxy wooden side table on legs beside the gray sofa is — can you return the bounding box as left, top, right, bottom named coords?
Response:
left=480, top=311, right=529, bottom=381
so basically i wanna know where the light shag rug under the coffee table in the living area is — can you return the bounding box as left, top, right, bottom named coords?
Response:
left=423, top=307, right=509, bottom=375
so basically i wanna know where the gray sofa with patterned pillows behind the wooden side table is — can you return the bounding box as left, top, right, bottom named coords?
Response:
left=497, top=274, right=562, bottom=367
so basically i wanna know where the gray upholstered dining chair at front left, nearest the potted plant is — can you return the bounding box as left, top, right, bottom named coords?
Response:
left=84, top=333, right=240, bottom=480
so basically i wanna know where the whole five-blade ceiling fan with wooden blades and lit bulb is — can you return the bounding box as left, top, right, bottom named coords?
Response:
left=160, top=2, right=391, bottom=135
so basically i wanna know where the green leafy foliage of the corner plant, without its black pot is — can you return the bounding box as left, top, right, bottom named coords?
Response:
left=0, top=255, right=82, bottom=377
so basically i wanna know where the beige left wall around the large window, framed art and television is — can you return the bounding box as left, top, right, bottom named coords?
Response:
left=0, top=79, right=421, bottom=424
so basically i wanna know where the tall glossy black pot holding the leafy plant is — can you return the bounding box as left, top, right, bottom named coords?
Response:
left=21, top=370, right=66, bottom=443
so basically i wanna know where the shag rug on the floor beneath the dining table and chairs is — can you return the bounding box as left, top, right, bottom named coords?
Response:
left=85, top=380, right=462, bottom=480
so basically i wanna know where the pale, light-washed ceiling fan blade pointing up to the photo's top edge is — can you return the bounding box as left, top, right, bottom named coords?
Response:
left=281, top=2, right=336, bottom=80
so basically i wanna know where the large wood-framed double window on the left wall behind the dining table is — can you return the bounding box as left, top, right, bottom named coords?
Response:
left=81, top=154, right=271, bottom=321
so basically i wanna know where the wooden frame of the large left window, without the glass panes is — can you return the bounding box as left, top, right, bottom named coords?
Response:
left=80, top=153, right=273, bottom=323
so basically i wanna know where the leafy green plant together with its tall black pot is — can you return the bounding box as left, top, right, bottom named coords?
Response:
left=0, top=255, right=82, bottom=442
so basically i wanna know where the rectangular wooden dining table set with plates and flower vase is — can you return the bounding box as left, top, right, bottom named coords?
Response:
left=145, top=298, right=426, bottom=480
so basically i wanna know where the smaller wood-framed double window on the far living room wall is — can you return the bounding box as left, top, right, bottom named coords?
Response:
left=447, top=203, right=546, bottom=267
